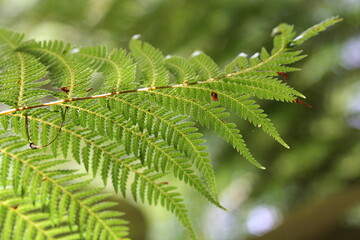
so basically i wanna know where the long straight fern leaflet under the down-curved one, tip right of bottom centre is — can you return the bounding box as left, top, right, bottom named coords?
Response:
left=55, top=103, right=221, bottom=207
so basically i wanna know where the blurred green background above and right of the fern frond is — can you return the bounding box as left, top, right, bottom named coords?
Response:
left=0, top=0, right=360, bottom=240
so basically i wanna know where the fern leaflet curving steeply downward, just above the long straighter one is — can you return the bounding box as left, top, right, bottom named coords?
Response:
left=104, top=95, right=217, bottom=199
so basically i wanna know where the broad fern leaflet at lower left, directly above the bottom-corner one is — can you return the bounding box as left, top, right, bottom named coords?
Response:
left=0, top=136, right=127, bottom=239
